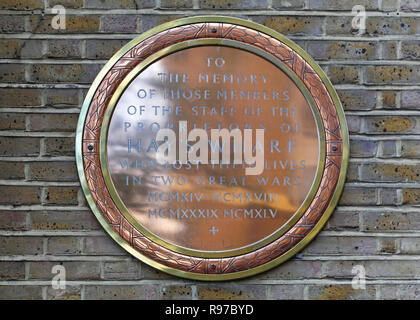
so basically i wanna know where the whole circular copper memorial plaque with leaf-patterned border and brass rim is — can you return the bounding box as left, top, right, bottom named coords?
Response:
left=76, top=17, right=348, bottom=280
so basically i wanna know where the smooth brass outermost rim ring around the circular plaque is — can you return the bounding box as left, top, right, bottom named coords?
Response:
left=76, top=16, right=349, bottom=280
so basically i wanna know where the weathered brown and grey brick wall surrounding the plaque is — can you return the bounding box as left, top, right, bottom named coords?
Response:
left=0, top=0, right=420, bottom=299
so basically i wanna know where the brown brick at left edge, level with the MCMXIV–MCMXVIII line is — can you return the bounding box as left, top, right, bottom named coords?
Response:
left=0, top=186, right=41, bottom=206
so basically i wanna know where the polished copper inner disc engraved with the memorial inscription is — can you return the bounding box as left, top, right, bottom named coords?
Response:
left=107, top=46, right=320, bottom=252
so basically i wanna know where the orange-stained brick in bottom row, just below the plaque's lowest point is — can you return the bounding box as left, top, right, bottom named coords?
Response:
left=197, top=283, right=267, bottom=300
